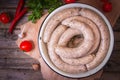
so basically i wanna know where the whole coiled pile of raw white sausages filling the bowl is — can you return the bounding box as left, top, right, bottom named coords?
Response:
left=43, top=7, right=110, bottom=74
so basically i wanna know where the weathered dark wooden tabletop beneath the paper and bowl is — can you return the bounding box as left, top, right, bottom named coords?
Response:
left=0, top=0, right=120, bottom=80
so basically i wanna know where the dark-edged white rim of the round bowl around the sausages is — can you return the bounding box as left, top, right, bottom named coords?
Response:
left=38, top=3, right=114, bottom=78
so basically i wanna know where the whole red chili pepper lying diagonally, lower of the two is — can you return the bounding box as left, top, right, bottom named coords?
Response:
left=8, top=8, right=28, bottom=33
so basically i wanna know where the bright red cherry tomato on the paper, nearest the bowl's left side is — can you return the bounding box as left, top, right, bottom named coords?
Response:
left=20, top=40, right=33, bottom=52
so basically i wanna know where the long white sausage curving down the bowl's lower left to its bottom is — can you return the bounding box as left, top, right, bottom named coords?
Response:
left=48, top=25, right=86, bottom=73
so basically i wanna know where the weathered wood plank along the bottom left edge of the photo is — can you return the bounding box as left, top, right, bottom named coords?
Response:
left=0, top=69, right=43, bottom=80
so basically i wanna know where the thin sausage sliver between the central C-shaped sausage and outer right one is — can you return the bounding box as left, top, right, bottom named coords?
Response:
left=60, top=16, right=100, bottom=54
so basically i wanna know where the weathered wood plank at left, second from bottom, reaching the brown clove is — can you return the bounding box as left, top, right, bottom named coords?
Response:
left=0, top=58, right=40, bottom=70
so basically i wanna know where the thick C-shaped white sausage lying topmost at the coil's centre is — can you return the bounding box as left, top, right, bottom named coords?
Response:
left=55, top=19, right=94, bottom=58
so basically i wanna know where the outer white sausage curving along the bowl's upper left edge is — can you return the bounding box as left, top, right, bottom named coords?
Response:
left=43, top=8, right=80, bottom=43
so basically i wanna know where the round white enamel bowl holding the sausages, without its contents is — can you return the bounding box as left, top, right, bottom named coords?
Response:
left=38, top=3, right=114, bottom=78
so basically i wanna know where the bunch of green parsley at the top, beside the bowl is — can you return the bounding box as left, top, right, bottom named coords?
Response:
left=27, top=0, right=62, bottom=22
